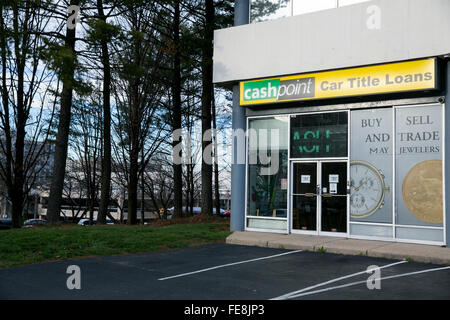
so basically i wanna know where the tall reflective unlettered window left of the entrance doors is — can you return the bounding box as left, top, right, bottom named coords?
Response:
left=247, top=117, right=289, bottom=224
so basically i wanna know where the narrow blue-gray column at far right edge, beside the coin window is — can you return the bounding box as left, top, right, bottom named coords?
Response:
left=444, top=59, right=450, bottom=247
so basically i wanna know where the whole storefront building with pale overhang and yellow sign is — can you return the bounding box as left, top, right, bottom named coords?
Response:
left=214, top=0, right=450, bottom=246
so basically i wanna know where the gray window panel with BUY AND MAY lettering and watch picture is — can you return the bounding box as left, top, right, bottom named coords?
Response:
left=350, top=108, right=393, bottom=224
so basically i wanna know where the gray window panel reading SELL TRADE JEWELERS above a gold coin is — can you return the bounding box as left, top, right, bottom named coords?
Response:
left=395, top=105, right=444, bottom=227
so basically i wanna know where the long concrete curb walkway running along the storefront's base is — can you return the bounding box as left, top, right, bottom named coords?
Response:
left=226, top=231, right=450, bottom=265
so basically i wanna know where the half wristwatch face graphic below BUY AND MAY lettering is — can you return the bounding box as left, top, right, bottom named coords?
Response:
left=350, top=161, right=390, bottom=219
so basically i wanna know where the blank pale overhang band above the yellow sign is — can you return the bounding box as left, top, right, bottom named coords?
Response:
left=213, top=0, right=450, bottom=85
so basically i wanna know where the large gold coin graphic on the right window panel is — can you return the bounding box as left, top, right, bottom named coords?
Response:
left=402, top=160, right=443, bottom=223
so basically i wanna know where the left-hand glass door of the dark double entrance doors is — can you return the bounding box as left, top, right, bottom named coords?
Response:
left=291, top=162, right=319, bottom=231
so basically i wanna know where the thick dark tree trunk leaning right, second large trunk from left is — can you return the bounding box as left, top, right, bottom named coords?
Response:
left=47, top=0, right=80, bottom=224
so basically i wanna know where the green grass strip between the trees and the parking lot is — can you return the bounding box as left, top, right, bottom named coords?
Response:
left=0, top=222, right=230, bottom=268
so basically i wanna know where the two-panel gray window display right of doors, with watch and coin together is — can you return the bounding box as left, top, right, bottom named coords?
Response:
left=350, top=105, right=444, bottom=242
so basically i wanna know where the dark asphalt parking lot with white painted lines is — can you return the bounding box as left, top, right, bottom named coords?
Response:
left=0, top=243, right=450, bottom=300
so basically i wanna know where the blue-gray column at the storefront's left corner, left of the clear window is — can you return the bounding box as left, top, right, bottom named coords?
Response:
left=230, top=0, right=250, bottom=231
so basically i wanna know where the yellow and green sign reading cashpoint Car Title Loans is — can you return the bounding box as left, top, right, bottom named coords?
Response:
left=240, top=58, right=438, bottom=106
